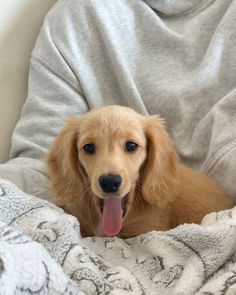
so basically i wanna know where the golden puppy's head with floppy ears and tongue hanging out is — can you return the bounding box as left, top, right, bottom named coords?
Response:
left=48, top=106, right=177, bottom=236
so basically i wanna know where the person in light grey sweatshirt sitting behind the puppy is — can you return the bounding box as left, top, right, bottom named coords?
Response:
left=0, top=0, right=236, bottom=199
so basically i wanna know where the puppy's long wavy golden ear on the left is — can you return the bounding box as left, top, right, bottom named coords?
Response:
left=46, top=118, right=83, bottom=205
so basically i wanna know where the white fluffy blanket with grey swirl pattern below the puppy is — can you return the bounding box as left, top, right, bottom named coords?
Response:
left=0, top=179, right=236, bottom=295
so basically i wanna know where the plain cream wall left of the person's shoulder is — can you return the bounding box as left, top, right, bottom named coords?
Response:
left=0, top=0, right=56, bottom=163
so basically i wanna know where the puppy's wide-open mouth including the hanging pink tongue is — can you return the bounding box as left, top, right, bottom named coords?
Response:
left=99, top=194, right=129, bottom=236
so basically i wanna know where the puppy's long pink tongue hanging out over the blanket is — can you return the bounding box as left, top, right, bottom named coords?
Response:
left=102, top=197, right=122, bottom=236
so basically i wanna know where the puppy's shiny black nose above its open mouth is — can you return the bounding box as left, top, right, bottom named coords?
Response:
left=99, top=174, right=122, bottom=193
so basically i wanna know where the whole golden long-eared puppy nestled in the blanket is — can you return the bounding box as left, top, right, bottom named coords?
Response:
left=47, top=106, right=232, bottom=238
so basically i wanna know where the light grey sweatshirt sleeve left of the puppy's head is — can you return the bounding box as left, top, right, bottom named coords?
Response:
left=0, top=18, right=88, bottom=198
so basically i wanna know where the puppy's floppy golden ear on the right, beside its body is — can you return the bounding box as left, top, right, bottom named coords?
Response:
left=141, top=116, right=178, bottom=206
